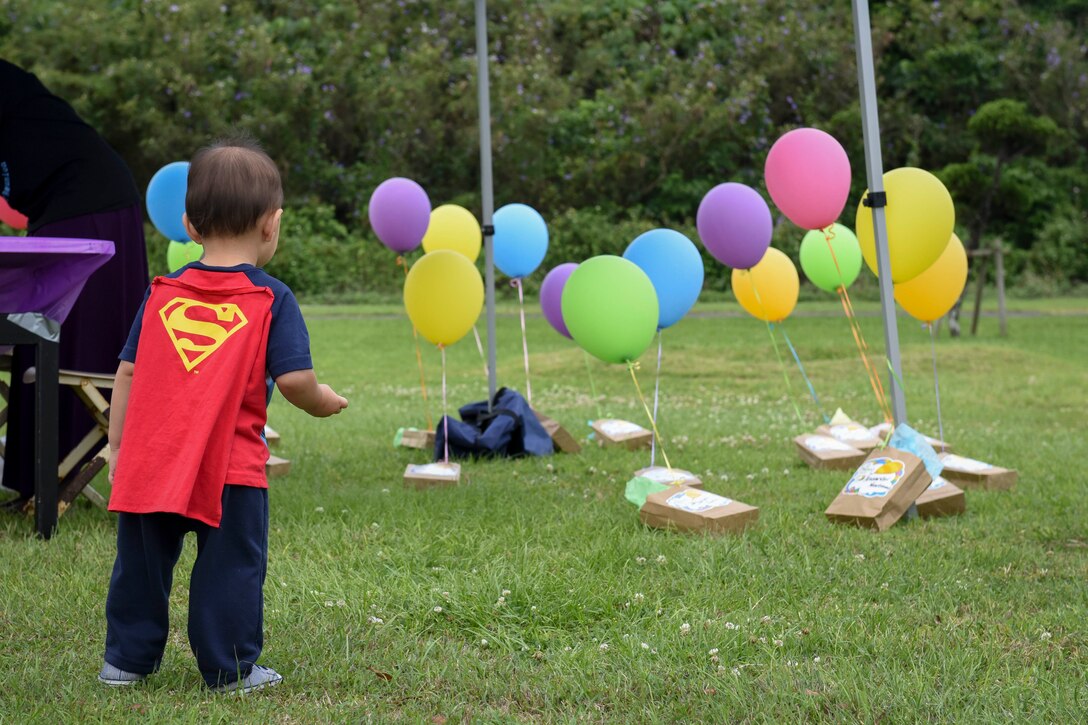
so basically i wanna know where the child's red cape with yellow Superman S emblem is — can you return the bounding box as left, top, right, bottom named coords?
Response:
left=110, top=269, right=273, bottom=526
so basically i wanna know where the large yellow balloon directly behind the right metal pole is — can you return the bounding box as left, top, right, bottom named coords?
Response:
left=854, top=167, right=955, bottom=284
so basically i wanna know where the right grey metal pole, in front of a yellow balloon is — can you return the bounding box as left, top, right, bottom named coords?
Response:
left=853, top=0, right=906, bottom=426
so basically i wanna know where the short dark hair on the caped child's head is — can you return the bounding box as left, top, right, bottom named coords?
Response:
left=185, top=136, right=283, bottom=236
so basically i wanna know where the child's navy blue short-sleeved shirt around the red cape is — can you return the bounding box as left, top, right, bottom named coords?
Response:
left=119, top=261, right=313, bottom=383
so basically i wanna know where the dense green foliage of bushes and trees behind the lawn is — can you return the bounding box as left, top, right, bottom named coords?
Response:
left=0, top=0, right=1088, bottom=288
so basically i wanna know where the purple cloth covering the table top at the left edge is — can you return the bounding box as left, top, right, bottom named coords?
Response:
left=0, top=236, right=113, bottom=322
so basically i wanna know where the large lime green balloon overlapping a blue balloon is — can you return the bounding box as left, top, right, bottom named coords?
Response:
left=561, top=255, right=658, bottom=364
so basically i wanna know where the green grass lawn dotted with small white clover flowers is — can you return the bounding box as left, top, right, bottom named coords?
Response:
left=0, top=299, right=1088, bottom=723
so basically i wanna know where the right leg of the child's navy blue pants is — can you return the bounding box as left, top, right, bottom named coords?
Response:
left=189, top=486, right=269, bottom=687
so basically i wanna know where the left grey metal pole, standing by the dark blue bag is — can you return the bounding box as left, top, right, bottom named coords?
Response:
left=475, top=0, right=498, bottom=407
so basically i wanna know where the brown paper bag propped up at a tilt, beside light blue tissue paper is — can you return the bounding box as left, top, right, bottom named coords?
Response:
left=826, top=448, right=932, bottom=531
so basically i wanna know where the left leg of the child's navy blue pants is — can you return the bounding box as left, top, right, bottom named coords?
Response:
left=106, top=513, right=193, bottom=675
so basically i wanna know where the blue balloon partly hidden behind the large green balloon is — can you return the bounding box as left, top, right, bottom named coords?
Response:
left=623, top=229, right=703, bottom=330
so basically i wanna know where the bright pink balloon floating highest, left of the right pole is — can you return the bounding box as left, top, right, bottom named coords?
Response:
left=763, top=128, right=850, bottom=229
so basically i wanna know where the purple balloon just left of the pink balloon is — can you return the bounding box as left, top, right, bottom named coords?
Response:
left=695, top=182, right=772, bottom=269
